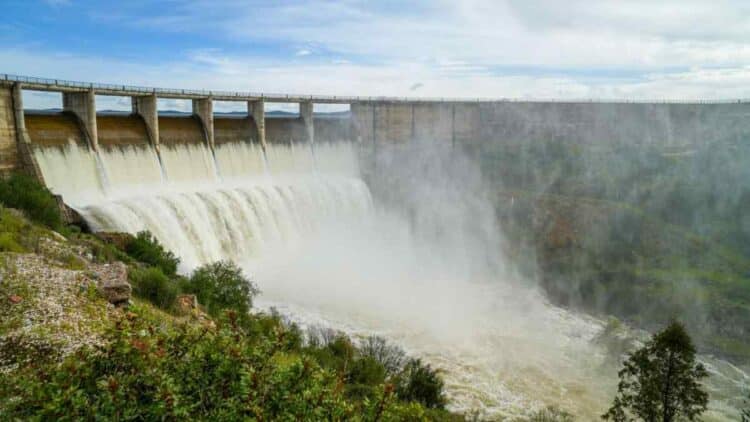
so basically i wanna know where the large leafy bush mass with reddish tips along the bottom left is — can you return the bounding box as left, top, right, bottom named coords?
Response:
left=0, top=307, right=356, bottom=420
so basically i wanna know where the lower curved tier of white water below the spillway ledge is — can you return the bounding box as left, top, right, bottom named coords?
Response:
left=80, top=179, right=370, bottom=270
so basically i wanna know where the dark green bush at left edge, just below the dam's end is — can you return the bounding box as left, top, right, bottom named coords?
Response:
left=0, top=173, right=63, bottom=230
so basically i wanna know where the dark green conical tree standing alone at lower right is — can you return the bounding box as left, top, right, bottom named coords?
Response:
left=602, top=322, right=708, bottom=422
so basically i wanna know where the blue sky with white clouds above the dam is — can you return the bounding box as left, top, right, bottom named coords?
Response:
left=0, top=0, right=750, bottom=109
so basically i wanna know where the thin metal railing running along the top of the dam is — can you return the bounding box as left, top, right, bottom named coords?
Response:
left=0, top=74, right=750, bottom=104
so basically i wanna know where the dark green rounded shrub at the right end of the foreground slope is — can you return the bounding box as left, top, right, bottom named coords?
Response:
left=396, top=359, right=446, bottom=409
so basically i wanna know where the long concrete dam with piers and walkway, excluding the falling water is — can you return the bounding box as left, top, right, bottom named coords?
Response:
left=0, top=74, right=750, bottom=190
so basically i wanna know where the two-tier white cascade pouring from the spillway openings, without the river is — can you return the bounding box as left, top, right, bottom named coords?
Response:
left=35, top=138, right=372, bottom=272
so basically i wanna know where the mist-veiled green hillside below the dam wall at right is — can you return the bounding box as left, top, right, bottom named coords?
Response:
left=476, top=136, right=750, bottom=362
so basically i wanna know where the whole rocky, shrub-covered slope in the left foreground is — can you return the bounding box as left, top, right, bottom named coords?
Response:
left=0, top=178, right=463, bottom=421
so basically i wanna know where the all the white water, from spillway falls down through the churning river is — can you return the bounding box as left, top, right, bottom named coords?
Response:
left=35, top=138, right=748, bottom=420
